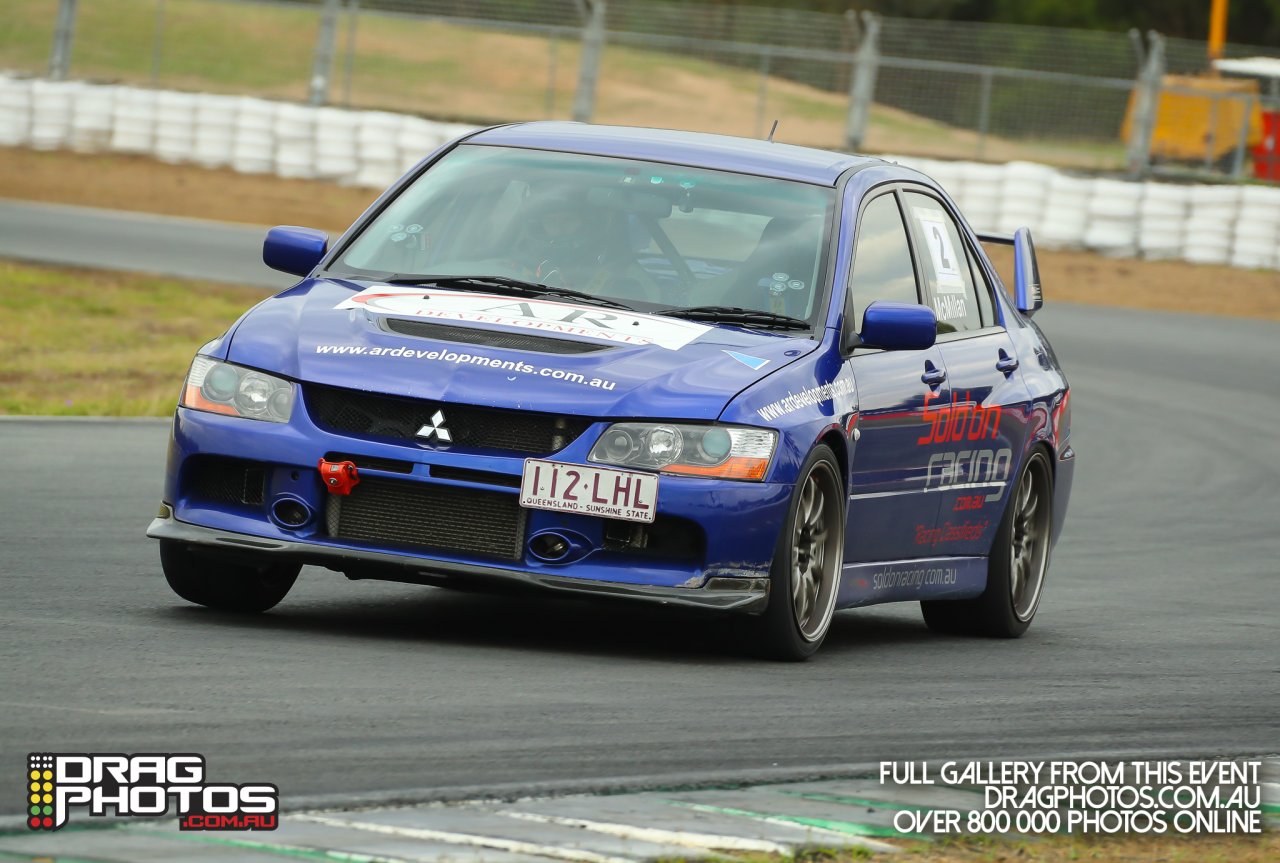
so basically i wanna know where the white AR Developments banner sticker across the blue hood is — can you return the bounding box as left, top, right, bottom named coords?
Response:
left=334, top=286, right=710, bottom=351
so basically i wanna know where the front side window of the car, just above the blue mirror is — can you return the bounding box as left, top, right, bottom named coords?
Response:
left=849, top=192, right=920, bottom=330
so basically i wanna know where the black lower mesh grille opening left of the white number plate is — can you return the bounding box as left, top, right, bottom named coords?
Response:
left=325, top=476, right=526, bottom=561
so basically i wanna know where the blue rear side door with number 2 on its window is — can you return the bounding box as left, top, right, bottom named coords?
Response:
left=901, top=187, right=1029, bottom=556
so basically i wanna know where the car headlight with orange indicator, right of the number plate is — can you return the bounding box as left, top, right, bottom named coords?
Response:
left=586, top=423, right=778, bottom=481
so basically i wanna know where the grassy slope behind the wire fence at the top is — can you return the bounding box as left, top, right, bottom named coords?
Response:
left=0, top=0, right=1123, bottom=168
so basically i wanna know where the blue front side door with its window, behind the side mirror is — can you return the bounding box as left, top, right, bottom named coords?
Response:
left=845, top=187, right=950, bottom=563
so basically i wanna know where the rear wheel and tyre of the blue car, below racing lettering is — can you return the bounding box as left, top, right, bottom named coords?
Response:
left=920, top=449, right=1053, bottom=638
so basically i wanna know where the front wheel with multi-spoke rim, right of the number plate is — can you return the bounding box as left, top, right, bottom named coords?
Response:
left=750, top=446, right=845, bottom=662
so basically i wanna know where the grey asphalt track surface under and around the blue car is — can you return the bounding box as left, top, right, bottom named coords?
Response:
left=0, top=202, right=1280, bottom=814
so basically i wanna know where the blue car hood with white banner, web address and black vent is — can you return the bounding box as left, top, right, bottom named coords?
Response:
left=227, top=279, right=818, bottom=420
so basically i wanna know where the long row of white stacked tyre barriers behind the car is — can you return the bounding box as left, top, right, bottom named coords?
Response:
left=0, top=73, right=1280, bottom=269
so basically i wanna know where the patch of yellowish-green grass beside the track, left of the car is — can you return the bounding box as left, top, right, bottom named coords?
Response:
left=0, top=260, right=266, bottom=416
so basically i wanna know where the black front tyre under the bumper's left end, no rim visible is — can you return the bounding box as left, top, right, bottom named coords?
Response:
left=160, top=539, right=302, bottom=613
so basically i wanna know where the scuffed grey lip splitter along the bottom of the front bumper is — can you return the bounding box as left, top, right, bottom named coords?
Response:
left=147, top=515, right=769, bottom=612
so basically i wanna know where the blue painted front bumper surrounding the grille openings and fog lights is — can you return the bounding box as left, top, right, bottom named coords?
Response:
left=163, top=397, right=791, bottom=591
